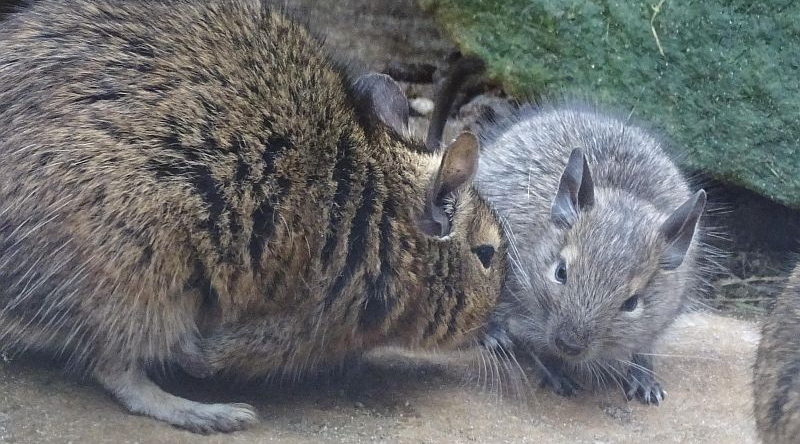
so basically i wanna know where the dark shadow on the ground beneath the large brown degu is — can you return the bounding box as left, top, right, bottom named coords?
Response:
left=3, top=353, right=466, bottom=416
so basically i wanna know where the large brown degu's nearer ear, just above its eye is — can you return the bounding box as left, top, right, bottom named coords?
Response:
left=418, top=132, right=479, bottom=237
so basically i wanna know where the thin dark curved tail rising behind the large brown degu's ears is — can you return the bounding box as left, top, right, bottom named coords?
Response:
left=425, top=56, right=486, bottom=152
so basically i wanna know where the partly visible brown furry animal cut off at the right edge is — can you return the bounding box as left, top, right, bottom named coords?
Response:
left=753, top=265, right=800, bottom=444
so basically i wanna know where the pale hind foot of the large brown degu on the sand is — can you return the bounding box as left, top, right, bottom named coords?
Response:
left=94, top=364, right=257, bottom=433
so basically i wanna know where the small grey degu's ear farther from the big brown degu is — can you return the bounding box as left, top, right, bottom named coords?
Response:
left=660, top=190, right=706, bottom=270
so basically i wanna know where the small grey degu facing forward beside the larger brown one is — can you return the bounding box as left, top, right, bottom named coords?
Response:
left=428, top=59, right=707, bottom=404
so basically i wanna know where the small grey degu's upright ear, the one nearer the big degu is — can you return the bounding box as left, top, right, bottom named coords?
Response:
left=550, top=148, right=594, bottom=228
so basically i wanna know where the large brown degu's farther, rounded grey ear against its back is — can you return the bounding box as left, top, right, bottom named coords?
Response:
left=353, top=72, right=409, bottom=135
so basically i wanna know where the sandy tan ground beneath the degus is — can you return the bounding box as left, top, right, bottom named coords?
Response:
left=0, top=314, right=758, bottom=444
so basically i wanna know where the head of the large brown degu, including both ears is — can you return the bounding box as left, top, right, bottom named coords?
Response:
left=355, top=73, right=506, bottom=348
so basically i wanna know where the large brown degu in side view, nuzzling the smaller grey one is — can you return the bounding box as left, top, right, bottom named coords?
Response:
left=0, top=0, right=505, bottom=432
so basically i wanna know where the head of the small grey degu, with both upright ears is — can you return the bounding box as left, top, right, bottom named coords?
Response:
left=508, top=150, right=705, bottom=366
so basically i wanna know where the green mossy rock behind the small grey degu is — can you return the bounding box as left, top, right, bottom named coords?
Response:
left=421, top=0, right=800, bottom=208
